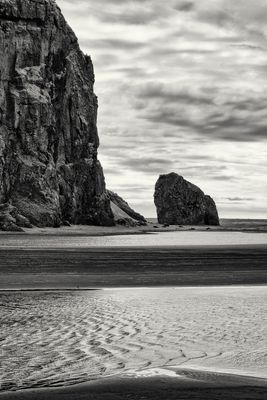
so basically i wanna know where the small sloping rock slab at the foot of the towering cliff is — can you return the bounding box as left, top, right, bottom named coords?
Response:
left=107, top=190, right=146, bottom=226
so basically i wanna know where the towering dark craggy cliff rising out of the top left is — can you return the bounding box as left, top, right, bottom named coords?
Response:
left=0, top=0, right=114, bottom=226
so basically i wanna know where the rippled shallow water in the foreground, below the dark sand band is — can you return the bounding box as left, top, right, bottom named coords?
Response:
left=0, top=286, right=267, bottom=390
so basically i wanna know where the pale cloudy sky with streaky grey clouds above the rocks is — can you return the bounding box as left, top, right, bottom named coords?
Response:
left=57, top=0, right=267, bottom=218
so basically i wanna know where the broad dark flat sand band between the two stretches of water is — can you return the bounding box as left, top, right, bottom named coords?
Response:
left=0, top=245, right=267, bottom=289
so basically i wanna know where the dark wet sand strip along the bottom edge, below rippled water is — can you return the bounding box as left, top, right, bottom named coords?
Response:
left=0, top=368, right=267, bottom=400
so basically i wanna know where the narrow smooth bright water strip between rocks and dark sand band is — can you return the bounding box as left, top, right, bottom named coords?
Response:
left=0, top=231, right=267, bottom=248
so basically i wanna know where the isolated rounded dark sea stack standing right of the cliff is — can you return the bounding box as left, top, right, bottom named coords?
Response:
left=154, top=173, right=220, bottom=225
